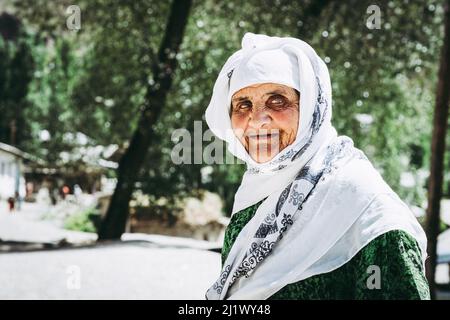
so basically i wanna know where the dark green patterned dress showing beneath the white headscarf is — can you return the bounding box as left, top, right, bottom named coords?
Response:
left=222, top=201, right=430, bottom=300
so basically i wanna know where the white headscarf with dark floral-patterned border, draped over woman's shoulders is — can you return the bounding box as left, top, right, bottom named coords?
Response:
left=205, top=33, right=426, bottom=299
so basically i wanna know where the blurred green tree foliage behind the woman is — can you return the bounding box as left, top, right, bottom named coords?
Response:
left=0, top=0, right=442, bottom=214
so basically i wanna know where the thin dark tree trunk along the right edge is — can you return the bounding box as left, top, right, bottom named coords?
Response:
left=426, top=0, right=450, bottom=299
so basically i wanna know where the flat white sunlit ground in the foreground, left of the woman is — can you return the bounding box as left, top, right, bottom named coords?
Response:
left=0, top=243, right=220, bottom=300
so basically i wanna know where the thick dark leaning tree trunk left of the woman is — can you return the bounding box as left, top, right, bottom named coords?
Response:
left=99, top=0, right=192, bottom=240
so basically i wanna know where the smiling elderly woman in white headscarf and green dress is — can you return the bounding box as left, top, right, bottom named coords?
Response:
left=205, top=33, right=429, bottom=299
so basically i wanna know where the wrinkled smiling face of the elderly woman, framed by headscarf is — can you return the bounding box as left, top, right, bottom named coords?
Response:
left=230, top=83, right=300, bottom=163
